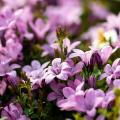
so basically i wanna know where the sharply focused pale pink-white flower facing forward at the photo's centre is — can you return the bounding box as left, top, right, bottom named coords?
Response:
left=45, top=58, right=71, bottom=84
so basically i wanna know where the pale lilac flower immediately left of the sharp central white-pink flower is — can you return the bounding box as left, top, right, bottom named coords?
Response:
left=22, top=60, right=49, bottom=89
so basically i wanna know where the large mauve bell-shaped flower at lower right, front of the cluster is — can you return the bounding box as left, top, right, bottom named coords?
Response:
left=76, top=88, right=103, bottom=117
